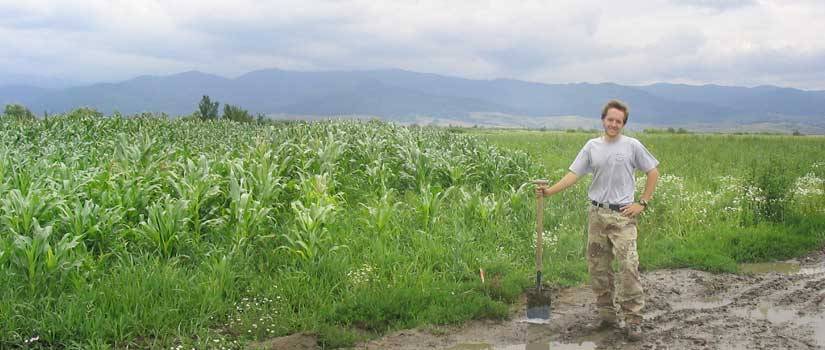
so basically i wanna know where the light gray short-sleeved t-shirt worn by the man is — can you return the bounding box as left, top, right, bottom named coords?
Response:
left=570, top=135, right=659, bottom=204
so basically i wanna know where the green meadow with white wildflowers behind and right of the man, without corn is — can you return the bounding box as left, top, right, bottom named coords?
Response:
left=473, top=130, right=825, bottom=272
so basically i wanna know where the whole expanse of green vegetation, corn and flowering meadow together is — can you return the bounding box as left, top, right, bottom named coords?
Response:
left=0, top=110, right=825, bottom=349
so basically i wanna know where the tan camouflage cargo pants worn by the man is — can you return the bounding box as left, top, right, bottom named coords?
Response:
left=587, top=206, right=645, bottom=324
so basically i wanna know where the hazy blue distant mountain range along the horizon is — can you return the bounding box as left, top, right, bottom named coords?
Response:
left=0, top=69, right=825, bottom=133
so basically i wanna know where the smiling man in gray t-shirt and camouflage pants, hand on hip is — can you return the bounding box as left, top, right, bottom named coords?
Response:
left=536, top=100, right=659, bottom=341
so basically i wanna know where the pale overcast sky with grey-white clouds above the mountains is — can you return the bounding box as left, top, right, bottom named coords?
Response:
left=0, top=0, right=825, bottom=90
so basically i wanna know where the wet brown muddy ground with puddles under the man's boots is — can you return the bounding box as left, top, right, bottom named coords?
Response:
left=260, top=247, right=825, bottom=350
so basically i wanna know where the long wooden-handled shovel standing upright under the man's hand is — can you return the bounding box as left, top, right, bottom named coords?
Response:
left=527, top=180, right=550, bottom=323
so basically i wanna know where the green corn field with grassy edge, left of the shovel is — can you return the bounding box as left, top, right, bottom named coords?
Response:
left=0, top=110, right=537, bottom=347
